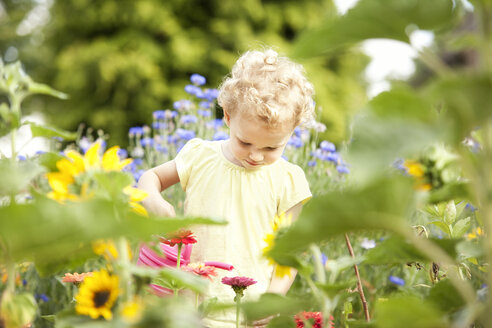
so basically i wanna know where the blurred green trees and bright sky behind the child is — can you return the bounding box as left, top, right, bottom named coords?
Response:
left=0, top=0, right=432, bottom=147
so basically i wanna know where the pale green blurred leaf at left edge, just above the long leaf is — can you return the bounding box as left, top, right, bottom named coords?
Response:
left=0, top=158, right=44, bottom=195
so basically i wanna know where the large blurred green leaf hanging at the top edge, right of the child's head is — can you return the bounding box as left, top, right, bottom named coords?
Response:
left=292, top=0, right=456, bottom=57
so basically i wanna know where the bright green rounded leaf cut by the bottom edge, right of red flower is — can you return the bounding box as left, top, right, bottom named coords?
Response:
left=374, top=295, right=449, bottom=328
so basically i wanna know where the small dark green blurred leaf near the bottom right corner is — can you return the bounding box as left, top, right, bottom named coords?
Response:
left=427, top=279, right=465, bottom=313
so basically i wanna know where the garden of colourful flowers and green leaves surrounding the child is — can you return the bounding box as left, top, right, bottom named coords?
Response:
left=0, top=0, right=492, bottom=328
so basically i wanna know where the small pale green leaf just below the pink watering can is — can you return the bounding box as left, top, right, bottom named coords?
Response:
left=153, top=268, right=208, bottom=293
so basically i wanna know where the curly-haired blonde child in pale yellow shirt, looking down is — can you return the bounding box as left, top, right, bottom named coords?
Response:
left=138, top=50, right=314, bottom=328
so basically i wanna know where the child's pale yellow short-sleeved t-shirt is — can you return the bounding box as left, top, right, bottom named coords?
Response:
left=175, top=139, right=312, bottom=328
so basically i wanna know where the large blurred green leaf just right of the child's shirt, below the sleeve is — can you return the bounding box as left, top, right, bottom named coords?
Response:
left=271, top=176, right=414, bottom=260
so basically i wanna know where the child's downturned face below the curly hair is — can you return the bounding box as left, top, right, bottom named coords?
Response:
left=224, top=112, right=294, bottom=169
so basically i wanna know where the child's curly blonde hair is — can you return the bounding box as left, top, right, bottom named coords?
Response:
left=217, top=49, right=314, bottom=128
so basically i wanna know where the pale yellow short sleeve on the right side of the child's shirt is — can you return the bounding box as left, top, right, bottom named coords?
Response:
left=278, top=164, right=313, bottom=214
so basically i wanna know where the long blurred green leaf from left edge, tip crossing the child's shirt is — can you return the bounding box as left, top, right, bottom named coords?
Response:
left=0, top=199, right=225, bottom=263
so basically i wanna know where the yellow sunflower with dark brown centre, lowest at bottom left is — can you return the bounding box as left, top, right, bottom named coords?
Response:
left=75, top=270, right=119, bottom=320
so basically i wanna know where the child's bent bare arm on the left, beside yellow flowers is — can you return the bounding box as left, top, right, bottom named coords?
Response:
left=138, top=160, right=179, bottom=216
